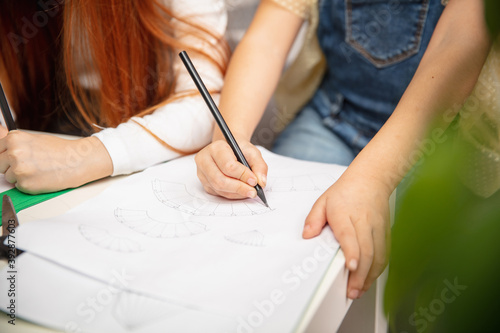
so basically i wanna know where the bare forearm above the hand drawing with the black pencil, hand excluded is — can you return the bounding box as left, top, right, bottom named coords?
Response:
left=214, top=1, right=303, bottom=140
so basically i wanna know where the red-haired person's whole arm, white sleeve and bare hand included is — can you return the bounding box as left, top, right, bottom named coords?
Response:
left=0, top=0, right=227, bottom=193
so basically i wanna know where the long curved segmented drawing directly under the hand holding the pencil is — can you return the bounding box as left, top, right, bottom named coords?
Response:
left=152, top=179, right=272, bottom=216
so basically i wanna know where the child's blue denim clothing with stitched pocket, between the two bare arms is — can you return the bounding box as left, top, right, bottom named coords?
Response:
left=273, top=0, right=444, bottom=165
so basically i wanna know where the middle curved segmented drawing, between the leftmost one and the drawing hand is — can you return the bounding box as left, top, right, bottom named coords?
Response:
left=115, top=208, right=208, bottom=238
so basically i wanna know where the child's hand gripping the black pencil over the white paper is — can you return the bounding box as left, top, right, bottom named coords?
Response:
left=195, top=140, right=267, bottom=199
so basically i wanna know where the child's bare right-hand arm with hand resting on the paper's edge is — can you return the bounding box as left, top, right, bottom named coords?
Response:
left=304, top=0, right=490, bottom=298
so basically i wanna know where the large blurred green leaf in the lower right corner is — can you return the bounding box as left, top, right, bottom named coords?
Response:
left=385, top=126, right=500, bottom=333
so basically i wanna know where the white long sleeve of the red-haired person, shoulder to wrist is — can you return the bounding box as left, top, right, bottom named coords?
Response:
left=94, top=0, right=227, bottom=176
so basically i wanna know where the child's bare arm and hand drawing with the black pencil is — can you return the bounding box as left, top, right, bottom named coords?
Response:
left=196, top=0, right=303, bottom=198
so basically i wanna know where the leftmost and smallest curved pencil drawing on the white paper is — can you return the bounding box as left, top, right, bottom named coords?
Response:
left=78, top=224, right=144, bottom=253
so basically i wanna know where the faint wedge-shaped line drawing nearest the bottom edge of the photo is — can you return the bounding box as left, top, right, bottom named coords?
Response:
left=112, top=291, right=187, bottom=331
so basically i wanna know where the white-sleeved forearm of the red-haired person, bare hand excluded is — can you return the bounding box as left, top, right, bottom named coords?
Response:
left=95, top=93, right=215, bottom=176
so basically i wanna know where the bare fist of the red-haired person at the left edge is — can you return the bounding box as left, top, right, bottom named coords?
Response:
left=0, top=131, right=113, bottom=194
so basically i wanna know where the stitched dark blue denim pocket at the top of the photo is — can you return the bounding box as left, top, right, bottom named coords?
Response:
left=345, top=0, right=429, bottom=68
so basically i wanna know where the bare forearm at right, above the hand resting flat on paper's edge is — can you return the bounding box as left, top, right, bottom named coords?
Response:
left=347, top=0, right=490, bottom=193
